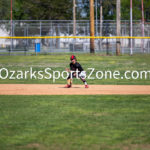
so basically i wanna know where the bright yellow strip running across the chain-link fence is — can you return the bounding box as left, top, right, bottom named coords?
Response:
left=0, top=36, right=150, bottom=39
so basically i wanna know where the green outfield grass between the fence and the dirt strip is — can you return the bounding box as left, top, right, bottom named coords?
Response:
left=0, top=54, right=150, bottom=85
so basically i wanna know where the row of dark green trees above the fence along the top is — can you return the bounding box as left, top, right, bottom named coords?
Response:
left=0, top=0, right=150, bottom=21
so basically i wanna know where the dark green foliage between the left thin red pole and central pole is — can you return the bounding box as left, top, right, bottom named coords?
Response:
left=14, top=0, right=72, bottom=20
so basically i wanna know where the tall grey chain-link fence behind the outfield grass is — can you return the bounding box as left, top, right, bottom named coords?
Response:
left=0, top=20, right=150, bottom=54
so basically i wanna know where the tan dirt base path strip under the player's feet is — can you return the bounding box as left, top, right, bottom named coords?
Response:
left=0, top=84, right=150, bottom=95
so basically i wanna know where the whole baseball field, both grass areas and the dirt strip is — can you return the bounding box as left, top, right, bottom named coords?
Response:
left=0, top=54, right=150, bottom=150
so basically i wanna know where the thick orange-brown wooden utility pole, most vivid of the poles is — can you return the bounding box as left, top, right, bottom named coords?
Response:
left=90, top=0, right=95, bottom=53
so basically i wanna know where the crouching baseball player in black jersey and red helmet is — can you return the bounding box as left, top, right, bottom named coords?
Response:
left=65, top=55, right=89, bottom=88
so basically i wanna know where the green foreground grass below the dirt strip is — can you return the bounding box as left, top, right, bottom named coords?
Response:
left=0, top=96, right=150, bottom=150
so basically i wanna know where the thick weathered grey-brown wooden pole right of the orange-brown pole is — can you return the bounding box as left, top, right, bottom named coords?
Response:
left=116, top=0, right=121, bottom=56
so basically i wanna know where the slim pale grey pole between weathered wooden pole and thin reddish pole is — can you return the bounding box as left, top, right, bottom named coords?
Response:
left=130, top=0, right=133, bottom=56
